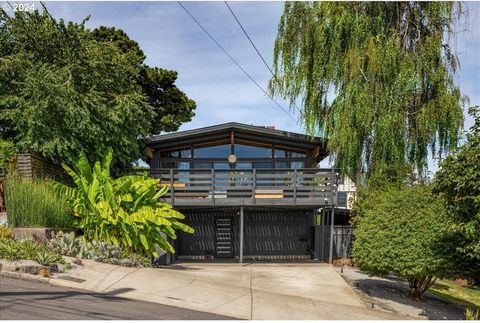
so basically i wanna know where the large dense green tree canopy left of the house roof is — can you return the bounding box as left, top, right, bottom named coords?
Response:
left=0, top=11, right=195, bottom=170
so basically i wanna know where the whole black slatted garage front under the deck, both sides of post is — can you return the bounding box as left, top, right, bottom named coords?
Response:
left=177, top=208, right=313, bottom=258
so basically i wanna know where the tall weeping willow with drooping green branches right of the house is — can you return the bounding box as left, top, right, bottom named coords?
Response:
left=269, top=2, right=466, bottom=185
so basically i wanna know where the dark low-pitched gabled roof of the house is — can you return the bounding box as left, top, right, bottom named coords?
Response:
left=147, top=122, right=327, bottom=158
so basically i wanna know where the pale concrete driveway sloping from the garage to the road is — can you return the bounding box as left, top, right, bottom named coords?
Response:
left=51, top=261, right=406, bottom=320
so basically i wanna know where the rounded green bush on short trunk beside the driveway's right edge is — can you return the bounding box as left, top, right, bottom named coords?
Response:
left=352, top=186, right=449, bottom=298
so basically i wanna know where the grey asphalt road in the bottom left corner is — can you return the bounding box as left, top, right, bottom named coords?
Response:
left=0, top=277, right=236, bottom=320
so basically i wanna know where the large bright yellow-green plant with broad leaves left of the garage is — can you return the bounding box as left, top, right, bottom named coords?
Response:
left=54, top=149, right=194, bottom=257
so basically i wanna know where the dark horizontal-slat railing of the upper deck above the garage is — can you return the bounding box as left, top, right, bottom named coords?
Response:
left=150, top=168, right=335, bottom=207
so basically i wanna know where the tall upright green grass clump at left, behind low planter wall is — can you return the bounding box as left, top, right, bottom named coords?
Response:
left=5, top=174, right=72, bottom=228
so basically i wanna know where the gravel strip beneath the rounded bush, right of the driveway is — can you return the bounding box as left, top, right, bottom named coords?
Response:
left=335, top=267, right=465, bottom=320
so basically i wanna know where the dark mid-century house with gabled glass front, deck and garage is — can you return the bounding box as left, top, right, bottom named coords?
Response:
left=147, top=123, right=348, bottom=263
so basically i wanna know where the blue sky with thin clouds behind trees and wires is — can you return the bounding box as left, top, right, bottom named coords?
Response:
left=8, top=2, right=480, bottom=170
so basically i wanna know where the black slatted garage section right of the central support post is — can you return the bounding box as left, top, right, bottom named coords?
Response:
left=237, top=209, right=313, bottom=256
